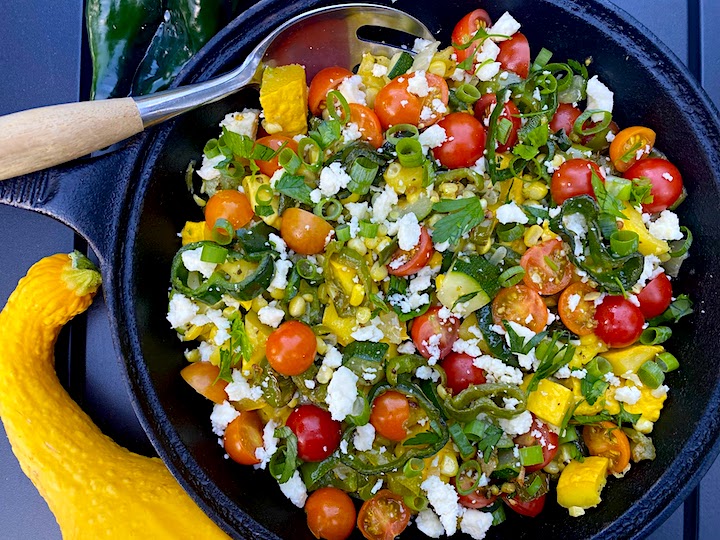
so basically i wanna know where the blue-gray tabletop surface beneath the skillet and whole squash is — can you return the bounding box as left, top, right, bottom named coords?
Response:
left=0, top=0, right=720, bottom=540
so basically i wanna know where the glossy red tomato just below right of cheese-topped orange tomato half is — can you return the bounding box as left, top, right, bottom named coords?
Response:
left=432, top=112, right=485, bottom=169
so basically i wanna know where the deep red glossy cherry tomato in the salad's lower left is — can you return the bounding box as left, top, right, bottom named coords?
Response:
left=285, top=404, right=342, bottom=462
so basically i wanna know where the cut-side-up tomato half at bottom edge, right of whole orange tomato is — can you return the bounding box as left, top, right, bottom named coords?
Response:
left=358, top=489, right=410, bottom=540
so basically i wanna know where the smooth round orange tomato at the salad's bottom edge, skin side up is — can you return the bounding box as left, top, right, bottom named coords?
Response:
left=305, top=487, right=357, bottom=540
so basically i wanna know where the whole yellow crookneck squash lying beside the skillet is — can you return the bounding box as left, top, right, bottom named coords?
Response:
left=0, top=253, right=227, bottom=540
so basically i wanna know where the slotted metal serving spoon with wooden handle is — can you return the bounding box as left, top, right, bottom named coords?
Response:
left=0, top=4, right=432, bottom=180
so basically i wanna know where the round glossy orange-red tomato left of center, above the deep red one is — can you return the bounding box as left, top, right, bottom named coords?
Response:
left=265, top=321, right=317, bottom=377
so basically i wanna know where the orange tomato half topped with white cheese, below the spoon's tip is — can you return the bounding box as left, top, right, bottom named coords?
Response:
left=375, top=73, right=449, bottom=129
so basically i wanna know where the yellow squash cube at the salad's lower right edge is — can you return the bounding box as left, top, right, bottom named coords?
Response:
left=557, top=456, right=610, bottom=509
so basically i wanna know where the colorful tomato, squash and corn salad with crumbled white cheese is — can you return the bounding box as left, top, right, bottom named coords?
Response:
left=168, top=9, right=692, bottom=539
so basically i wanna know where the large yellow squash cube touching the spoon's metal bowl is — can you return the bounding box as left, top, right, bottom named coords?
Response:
left=260, top=64, right=308, bottom=137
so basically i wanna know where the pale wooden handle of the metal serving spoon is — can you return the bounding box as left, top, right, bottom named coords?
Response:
left=0, top=98, right=143, bottom=180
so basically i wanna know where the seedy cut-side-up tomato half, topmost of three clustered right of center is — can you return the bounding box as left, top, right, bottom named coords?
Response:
left=520, top=238, right=573, bottom=295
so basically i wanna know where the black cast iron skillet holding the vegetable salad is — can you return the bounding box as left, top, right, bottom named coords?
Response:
left=0, top=0, right=720, bottom=538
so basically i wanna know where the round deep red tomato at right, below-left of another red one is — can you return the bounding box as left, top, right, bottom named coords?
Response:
left=595, top=296, right=645, bottom=348
